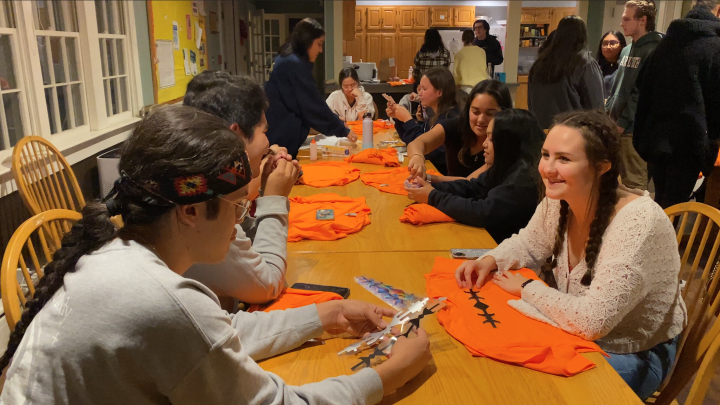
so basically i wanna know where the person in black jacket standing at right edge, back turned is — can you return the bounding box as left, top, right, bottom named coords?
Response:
left=633, top=0, right=720, bottom=208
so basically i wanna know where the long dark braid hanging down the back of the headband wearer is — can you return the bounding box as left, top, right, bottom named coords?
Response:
left=0, top=202, right=116, bottom=370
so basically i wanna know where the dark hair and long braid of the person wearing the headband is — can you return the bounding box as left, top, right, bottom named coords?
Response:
left=0, top=105, right=244, bottom=369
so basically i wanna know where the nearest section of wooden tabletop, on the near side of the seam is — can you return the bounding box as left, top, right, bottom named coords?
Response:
left=260, top=251, right=642, bottom=405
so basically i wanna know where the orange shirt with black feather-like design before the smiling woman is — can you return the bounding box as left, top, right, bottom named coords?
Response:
left=425, top=257, right=602, bottom=376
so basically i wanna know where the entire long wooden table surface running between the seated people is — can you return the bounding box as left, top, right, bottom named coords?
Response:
left=268, top=131, right=642, bottom=405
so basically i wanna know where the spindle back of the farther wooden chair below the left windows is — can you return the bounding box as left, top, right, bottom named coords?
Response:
left=12, top=136, right=85, bottom=215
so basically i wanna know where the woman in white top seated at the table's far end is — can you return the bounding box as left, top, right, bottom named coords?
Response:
left=326, top=68, right=375, bottom=122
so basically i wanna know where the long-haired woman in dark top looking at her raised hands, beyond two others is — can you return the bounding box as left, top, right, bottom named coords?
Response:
left=385, top=67, right=460, bottom=173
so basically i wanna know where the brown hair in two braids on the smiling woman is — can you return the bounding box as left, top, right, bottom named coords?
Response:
left=541, top=111, right=620, bottom=288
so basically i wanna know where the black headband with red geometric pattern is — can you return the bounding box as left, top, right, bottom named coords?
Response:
left=111, top=152, right=252, bottom=205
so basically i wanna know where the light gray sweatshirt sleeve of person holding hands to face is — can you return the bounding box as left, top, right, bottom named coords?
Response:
left=184, top=196, right=290, bottom=304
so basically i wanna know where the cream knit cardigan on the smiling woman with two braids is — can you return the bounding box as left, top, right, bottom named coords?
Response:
left=488, top=188, right=687, bottom=353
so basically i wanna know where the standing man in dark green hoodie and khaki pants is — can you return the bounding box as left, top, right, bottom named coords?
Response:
left=605, top=0, right=665, bottom=190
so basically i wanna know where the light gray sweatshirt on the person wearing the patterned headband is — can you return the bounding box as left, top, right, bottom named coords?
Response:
left=0, top=239, right=383, bottom=405
